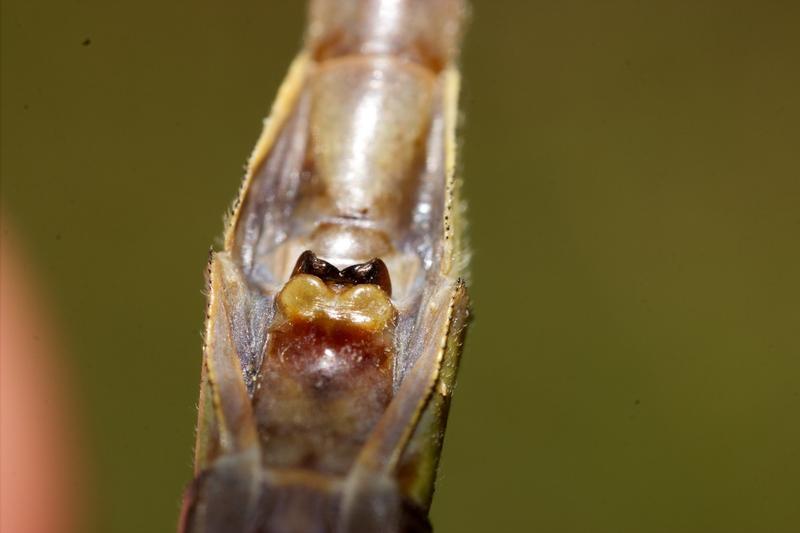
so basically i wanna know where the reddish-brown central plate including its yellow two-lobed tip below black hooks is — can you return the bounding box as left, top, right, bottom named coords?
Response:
left=254, top=274, right=396, bottom=474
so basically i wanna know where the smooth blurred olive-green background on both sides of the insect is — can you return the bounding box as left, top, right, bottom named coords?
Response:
left=2, top=0, right=800, bottom=533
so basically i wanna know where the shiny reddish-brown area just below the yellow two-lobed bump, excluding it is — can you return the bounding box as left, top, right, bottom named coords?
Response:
left=255, top=320, right=393, bottom=473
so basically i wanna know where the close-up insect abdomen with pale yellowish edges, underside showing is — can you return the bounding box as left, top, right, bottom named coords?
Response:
left=179, top=0, right=468, bottom=533
